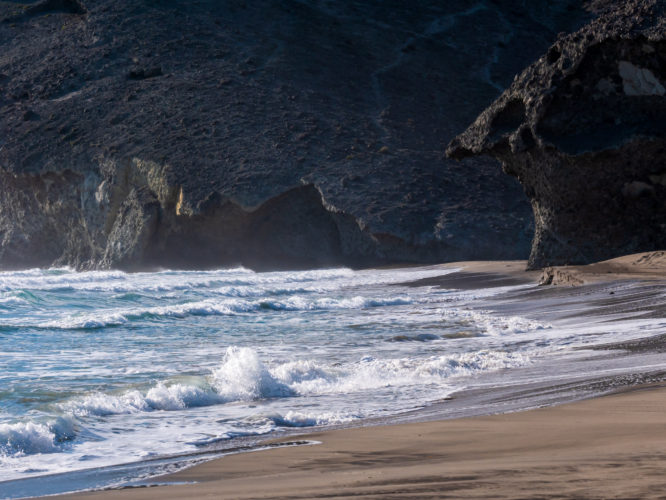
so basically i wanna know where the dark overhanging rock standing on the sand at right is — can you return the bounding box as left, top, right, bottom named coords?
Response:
left=447, top=0, right=666, bottom=268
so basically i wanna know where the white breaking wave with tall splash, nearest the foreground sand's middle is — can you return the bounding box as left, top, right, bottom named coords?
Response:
left=54, top=347, right=530, bottom=425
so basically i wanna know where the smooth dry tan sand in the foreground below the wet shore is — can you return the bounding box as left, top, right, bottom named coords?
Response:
left=65, top=387, right=666, bottom=500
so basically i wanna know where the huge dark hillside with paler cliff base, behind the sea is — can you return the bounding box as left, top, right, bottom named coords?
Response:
left=0, top=0, right=592, bottom=269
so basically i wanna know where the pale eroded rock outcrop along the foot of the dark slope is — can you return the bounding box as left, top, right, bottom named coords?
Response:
left=0, top=160, right=382, bottom=270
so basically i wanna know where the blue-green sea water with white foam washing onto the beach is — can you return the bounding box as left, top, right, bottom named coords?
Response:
left=0, top=266, right=666, bottom=498
